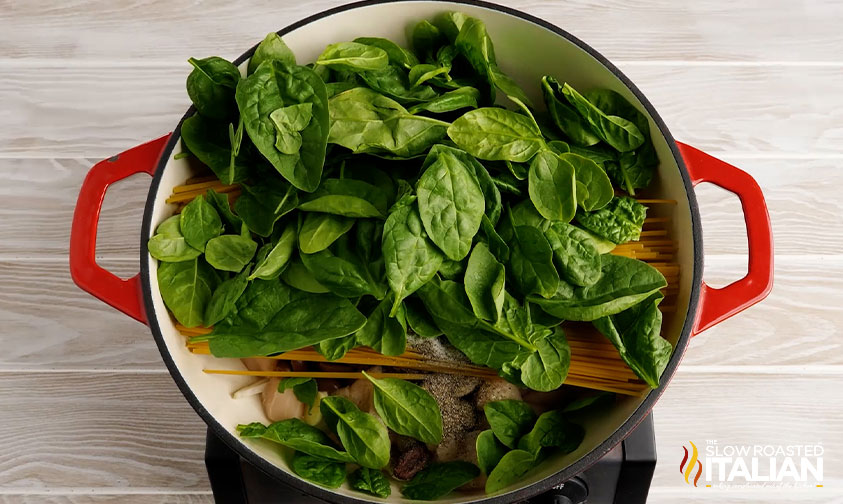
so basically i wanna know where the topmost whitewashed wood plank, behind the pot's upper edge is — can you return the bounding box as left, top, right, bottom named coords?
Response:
left=0, top=0, right=843, bottom=62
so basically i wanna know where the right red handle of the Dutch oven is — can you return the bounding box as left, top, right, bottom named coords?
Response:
left=677, top=142, right=773, bottom=335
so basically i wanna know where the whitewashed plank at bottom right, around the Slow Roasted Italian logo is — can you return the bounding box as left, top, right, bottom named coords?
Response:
left=653, top=367, right=843, bottom=488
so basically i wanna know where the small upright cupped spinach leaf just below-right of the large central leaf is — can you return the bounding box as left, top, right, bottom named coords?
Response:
left=464, top=243, right=506, bottom=322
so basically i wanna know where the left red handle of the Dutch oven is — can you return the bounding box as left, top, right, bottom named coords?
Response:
left=70, top=134, right=170, bottom=324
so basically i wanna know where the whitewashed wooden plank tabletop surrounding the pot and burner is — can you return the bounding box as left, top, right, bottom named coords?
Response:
left=0, top=0, right=843, bottom=504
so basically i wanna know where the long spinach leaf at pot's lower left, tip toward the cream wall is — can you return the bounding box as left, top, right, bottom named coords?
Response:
left=237, top=420, right=354, bottom=462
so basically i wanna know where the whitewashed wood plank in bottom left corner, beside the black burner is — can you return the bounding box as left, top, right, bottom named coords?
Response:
left=0, top=373, right=208, bottom=493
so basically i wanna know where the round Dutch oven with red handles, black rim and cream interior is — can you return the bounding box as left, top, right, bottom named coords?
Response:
left=70, top=1, right=773, bottom=503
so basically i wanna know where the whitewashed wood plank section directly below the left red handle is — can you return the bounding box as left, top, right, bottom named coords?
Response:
left=0, top=261, right=166, bottom=370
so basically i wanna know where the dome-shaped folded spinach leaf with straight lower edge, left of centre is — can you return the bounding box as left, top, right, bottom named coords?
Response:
left=299, top=178, right=388, bottom=218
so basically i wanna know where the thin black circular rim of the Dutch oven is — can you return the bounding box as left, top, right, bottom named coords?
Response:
left=140, top=0, right=703, bottom=504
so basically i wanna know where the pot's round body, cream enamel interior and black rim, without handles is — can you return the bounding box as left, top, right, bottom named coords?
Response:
left=141, top=1, right=702, bottom=502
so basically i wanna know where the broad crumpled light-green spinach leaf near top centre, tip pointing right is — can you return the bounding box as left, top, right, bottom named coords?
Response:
left=328, top=88, right=448, bottom=157
